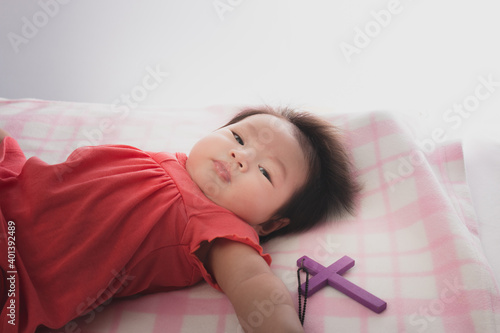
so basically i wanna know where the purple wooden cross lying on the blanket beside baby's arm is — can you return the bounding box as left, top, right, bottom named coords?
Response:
left=297, top=256, right=387, bottom=313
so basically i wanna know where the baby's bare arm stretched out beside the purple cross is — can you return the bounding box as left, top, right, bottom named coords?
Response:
left=208, top=239, right=304, bottom=333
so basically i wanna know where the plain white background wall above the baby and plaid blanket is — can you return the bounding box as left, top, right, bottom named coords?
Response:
left=0, top=0, right=500, bottom=133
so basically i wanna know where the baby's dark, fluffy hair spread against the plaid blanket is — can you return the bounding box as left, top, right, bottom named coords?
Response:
left=223, top=106, right=361, bottom=242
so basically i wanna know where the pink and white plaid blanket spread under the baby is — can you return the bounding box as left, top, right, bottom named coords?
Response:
left=0, top=100, right=500, bottom=333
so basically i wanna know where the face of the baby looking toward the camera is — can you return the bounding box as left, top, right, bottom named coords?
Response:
left=186, top=114, right=307, bottom=231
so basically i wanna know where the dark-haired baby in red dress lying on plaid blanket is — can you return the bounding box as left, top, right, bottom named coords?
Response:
left=0, top=107, right=359, bottom=333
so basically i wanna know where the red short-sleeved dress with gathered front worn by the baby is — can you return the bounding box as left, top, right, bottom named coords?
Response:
left=0, top=137, right=271, bottom=332
